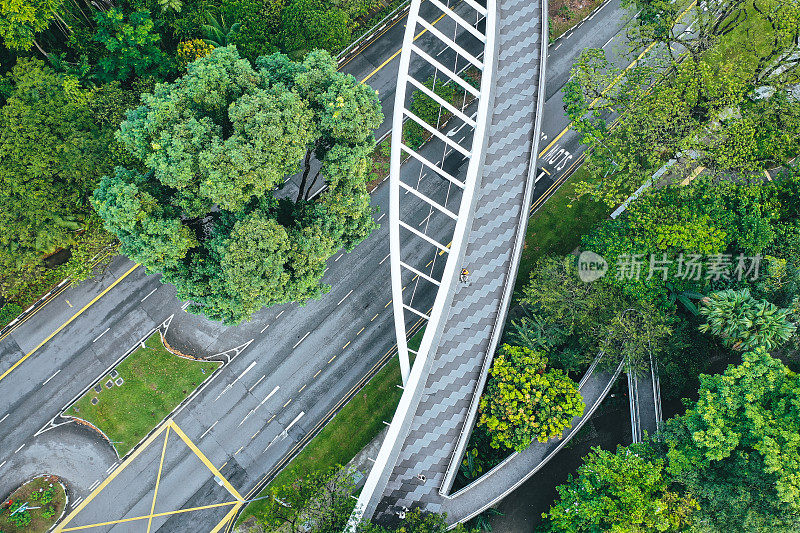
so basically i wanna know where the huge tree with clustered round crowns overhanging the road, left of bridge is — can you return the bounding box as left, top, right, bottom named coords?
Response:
left=94, top=47, right=383, bottom=324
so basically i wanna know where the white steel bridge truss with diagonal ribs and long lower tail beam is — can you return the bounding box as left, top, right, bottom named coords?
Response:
left=350, top=0, right=496, bottom=524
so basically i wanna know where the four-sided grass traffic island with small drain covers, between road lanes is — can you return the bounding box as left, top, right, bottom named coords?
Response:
left=66, top=332, right=221, bottom=457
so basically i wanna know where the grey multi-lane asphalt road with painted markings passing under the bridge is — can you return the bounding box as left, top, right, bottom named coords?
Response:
left=0, top=0, right=644, bottom=531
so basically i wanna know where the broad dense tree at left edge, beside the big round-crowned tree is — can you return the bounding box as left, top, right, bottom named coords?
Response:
left=0, top=59, right=114, bottom=292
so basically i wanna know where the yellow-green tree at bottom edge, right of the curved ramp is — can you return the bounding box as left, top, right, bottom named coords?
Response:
left=542, top=446, right=698, bottom=533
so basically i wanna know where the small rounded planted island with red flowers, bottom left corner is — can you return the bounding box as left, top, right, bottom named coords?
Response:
left=0, top=476, right=67, bottom=533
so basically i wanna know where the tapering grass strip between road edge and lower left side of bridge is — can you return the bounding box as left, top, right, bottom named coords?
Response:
left=237, top=329, right=425, bottom=524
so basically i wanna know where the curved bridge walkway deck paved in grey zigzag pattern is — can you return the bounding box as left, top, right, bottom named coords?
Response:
left=375, top=0, right=546, bottom=523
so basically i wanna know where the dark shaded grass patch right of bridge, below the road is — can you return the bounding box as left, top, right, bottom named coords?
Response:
left=516, top=166, right=611, bottom=288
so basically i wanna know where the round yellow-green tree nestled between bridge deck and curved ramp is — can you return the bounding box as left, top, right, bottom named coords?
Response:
left=478, top=344, right=584, bottom=451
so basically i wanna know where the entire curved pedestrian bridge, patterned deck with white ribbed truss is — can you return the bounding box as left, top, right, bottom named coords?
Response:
left=353, top=0, right=552, bottom=524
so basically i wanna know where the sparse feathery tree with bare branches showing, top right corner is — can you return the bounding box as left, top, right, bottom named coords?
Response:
left=564, top=0, right=800, bottom=206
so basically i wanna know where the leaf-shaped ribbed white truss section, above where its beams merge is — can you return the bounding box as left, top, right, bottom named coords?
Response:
left=389, top=0, right=495, bottom=386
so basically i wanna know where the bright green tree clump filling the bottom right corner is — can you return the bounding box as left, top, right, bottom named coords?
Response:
left=547, top=348, right=800, bottom=532
